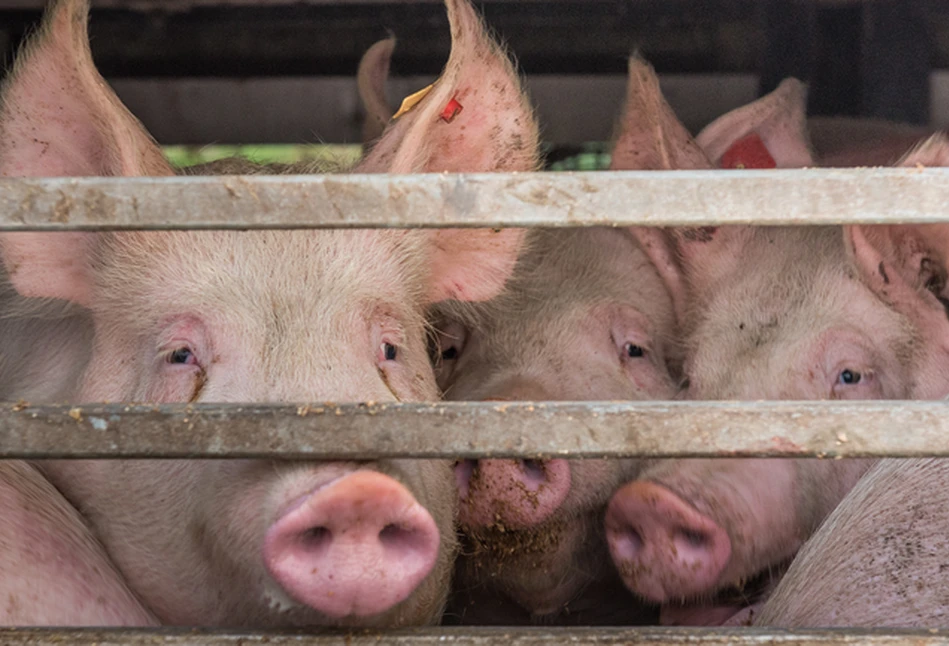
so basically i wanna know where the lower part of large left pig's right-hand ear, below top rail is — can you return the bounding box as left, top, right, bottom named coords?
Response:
left=428, top=229, right=525, bottom=303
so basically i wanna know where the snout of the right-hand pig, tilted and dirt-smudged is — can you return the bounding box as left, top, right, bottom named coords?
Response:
left=606, top=481, right=731, bottom=603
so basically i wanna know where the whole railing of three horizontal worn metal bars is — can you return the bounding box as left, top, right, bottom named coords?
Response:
left=0, top=169, right=949, bottom=646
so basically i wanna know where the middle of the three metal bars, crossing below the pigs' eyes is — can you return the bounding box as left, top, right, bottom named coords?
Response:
left=0, top=401, right=949, bottom=460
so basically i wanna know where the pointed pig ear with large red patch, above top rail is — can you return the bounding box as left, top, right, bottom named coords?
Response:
left=696, top=78, right=814, bottom=168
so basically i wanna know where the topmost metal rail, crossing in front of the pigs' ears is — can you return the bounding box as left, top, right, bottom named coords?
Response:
left=0, top=168, right=949, bottom=230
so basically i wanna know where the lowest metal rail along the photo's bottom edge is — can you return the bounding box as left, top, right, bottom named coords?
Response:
left=0, top=627, right=949, bottom=646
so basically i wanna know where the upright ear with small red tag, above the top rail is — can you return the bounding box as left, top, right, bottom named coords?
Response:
left=357, top=0, right=539, bottom=173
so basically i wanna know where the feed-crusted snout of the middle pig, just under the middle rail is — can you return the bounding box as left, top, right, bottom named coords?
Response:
left=455, top=460, right=570, bottom=529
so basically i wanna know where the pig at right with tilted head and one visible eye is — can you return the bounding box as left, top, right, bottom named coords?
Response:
left=605, top=78, right=949, bottom=624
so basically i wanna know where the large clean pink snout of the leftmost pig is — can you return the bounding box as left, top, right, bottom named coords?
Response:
left=264, top=471, right=439, bottom=618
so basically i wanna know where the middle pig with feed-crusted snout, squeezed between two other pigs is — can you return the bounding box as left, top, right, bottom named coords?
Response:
left=350, top=53, right=677, bottom=625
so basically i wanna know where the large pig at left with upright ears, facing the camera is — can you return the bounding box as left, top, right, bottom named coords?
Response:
left=0, top=0, right=538, bottom=627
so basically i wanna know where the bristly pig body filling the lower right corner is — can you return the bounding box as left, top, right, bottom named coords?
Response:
left=754, top=458, right=949, bottom=628
